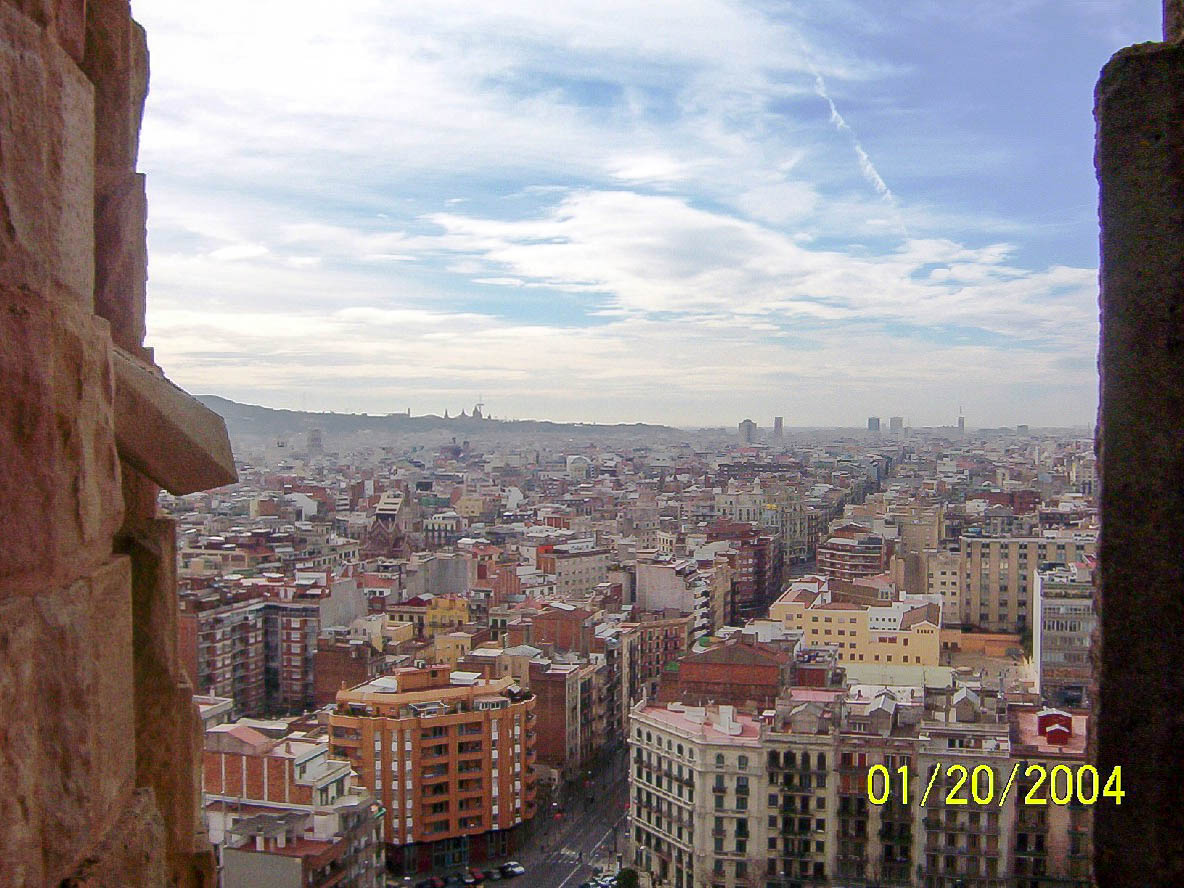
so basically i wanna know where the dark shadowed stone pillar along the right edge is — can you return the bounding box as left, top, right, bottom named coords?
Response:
left=1094, top=34, right=1184, bottom=888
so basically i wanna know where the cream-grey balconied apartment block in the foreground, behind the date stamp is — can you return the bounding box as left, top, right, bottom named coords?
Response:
left=629, top=686, right=1090, bottom=888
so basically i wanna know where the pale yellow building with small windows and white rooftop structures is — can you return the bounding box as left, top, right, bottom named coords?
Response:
left=768, top=577, right=941, bottom=665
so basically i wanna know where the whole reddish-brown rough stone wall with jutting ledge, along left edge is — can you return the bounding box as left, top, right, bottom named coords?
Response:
left=0, top=0, right=233, bottom=887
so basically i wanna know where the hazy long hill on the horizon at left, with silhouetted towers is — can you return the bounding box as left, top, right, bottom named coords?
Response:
left=198, top=394, right=677, bottom=438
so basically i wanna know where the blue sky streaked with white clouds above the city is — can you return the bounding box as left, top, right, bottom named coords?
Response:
left=127, top=0, right=1160, bottom=427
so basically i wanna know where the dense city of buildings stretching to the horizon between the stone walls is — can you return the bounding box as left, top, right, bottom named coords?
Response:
left=171, top=412, right=1098, bottom=888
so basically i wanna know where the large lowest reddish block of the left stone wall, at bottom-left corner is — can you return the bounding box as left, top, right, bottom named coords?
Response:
left=0, top=558, right=135, bottom=886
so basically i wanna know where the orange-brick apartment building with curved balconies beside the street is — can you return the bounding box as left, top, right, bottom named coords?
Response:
left=329, top=668, right=536, bottom=873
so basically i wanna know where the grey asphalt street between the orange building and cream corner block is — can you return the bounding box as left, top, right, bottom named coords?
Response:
left=519, top=749, right=629, bottom=888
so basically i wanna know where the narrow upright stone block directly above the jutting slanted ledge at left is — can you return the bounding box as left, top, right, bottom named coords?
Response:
left=95, top=173, right=148, bottom=350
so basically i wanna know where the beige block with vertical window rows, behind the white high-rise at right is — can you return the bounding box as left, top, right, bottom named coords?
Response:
left=960, top=530, right=1098, bottom=632
